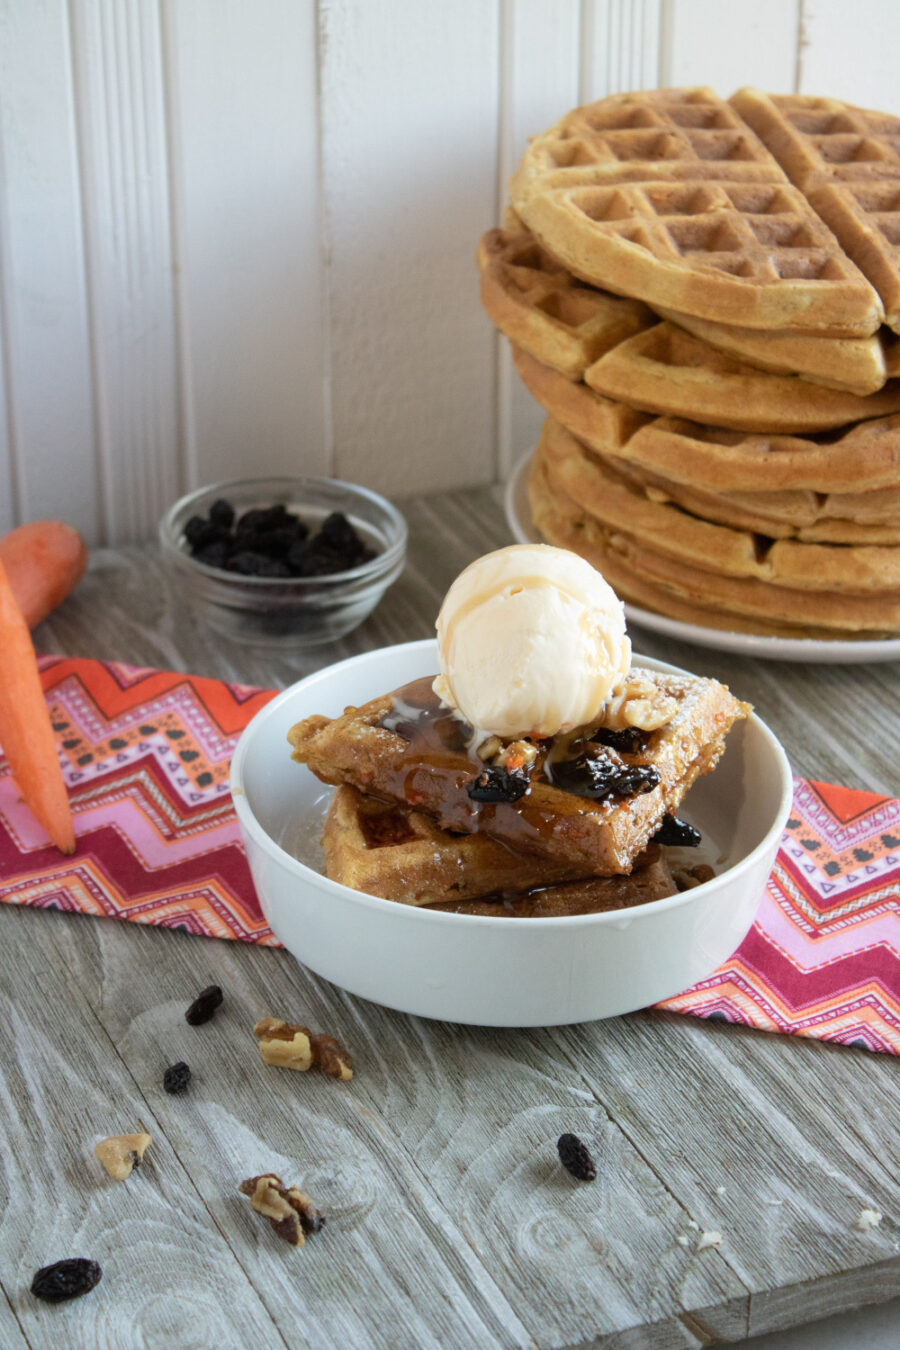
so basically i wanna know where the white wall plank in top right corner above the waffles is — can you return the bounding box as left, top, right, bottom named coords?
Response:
left=800, top=0, right=900, bottom=113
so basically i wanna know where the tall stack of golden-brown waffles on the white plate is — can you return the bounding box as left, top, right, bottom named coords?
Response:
left=478, top=89, right=900, bottom=639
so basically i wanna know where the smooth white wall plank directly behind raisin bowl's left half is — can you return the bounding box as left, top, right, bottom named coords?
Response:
left=163, top=0, right=331, bottom=486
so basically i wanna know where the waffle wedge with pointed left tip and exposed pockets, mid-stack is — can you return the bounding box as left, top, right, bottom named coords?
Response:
left=584, top=323, right=900, bottom=435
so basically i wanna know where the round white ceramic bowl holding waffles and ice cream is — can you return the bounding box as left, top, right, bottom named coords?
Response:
left=231, top=640, right=792, bottom=1026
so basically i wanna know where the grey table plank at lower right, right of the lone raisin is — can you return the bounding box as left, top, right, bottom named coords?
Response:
left=552, top=1014, right=900, bottom=1330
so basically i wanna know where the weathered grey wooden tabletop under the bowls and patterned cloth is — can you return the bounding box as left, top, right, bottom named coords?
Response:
left=0, top=489, right=900, bottom=1350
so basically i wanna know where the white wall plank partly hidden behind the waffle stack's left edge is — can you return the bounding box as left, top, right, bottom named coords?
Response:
left=496, top=0, right=580, bottom=478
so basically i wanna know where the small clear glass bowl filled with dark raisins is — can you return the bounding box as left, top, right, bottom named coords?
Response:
left=159, top=477, right=406, bottom=647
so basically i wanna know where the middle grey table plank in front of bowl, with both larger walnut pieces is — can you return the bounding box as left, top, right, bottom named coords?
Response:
left=38, top=907, right=748, bottom=1347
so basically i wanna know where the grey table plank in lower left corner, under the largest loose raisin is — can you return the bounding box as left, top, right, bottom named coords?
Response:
left=0, top=905, right=288, bottom=1350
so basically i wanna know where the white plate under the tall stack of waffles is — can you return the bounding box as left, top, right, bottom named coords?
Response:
left=505, top=454, right=900, bottom=666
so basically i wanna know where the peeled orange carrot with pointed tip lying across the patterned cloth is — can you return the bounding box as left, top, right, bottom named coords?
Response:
left=0, top=563, right=76, bottom=853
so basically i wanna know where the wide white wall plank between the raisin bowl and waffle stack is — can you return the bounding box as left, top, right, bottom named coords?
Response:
left=321, top=0, right=498, bottom=494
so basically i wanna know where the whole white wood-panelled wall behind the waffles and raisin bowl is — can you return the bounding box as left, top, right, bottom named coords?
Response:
left=0, top=0, right=900, bottom=543
